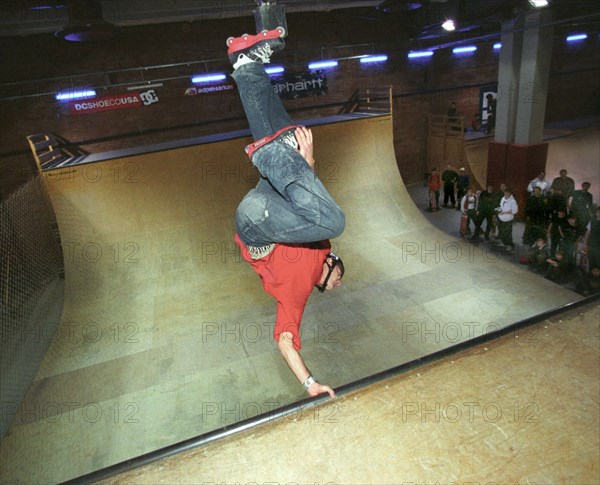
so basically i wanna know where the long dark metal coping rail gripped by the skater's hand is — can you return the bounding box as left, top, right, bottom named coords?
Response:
left=63, top=294, right=600, bottom=485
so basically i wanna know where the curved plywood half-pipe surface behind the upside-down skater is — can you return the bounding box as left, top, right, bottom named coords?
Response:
left=0, top=116, right=579, bottom=483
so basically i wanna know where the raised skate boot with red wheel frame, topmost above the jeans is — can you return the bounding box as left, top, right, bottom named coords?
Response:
left=227, top=27, right=285, bottom=65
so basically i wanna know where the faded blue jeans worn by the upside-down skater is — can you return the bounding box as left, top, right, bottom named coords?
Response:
left=232, top=62, right=345, bottom=246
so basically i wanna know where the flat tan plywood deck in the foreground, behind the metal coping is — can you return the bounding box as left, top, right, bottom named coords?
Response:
left=101, top=303, right=600, bottom=485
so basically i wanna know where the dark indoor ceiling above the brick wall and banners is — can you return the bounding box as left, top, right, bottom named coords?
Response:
left=0, top=0, right=600, bottom=42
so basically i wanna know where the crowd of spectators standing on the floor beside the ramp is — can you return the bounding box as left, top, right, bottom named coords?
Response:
left=428, top=164, right=600, bottom=296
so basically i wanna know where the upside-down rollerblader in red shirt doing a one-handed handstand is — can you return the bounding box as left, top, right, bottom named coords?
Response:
left=227, top=15, right=345, bottom=398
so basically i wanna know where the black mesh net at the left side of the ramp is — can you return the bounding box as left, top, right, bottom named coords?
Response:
left=0, top=175, right=64, bottom=439
